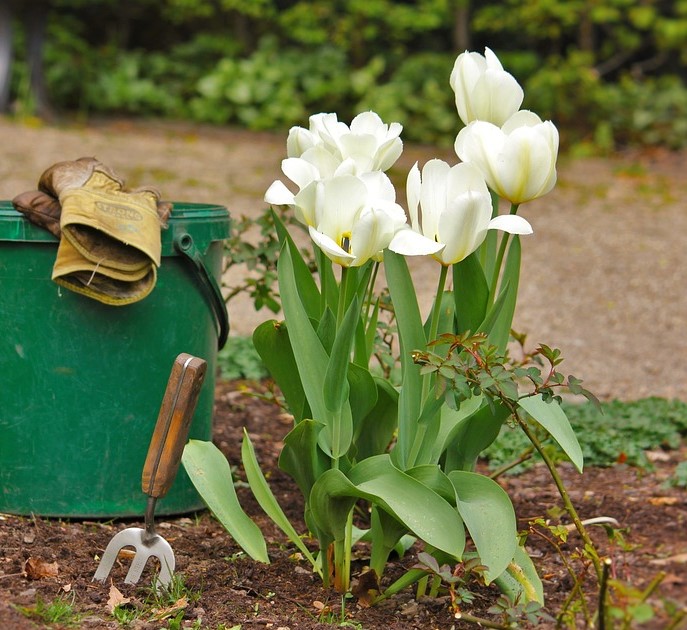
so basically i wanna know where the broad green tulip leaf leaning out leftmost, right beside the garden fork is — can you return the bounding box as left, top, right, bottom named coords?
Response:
left=181, top=440, right=270, bottom=564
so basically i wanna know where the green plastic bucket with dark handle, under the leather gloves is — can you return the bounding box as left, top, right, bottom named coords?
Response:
left=0, top=201, right=230, bottom=518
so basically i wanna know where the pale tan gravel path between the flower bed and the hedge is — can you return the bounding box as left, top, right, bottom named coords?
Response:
left=0, top=118, right=687, bottom=401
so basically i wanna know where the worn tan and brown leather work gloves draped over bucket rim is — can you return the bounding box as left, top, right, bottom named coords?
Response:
left=13, top=158, right=171, bottom=305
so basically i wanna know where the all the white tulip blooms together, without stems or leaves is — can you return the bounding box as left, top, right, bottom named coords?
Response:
left=265, top=48, right=558, bottom=267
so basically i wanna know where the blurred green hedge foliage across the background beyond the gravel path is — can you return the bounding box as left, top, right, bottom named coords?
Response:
left=1, top=0, right=687, bottom=151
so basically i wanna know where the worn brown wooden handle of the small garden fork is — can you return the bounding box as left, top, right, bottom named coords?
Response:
left=141, top=353, right=207, bottom=498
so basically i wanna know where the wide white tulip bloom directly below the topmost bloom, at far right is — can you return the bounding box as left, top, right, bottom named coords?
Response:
left=455, top=110, right=558, bottom=205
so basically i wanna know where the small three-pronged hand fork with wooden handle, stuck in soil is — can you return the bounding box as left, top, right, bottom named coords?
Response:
left=93, top=353, right=207, bottom=590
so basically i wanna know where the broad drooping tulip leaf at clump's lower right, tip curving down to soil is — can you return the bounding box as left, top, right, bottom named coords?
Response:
left=448, top=470, right=517, bottom=583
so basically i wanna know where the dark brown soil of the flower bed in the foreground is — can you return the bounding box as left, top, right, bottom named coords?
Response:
left=0, top=383, right=687, bottom=630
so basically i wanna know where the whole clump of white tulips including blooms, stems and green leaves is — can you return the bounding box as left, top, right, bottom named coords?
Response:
left=189, top=49, right=571, bottom=616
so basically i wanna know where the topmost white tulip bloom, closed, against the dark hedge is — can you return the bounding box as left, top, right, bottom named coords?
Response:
left=449, top=48, right=524, bottom=127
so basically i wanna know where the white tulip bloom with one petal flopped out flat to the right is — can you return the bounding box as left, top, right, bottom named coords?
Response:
left=407, top=160, right=532, bottom=266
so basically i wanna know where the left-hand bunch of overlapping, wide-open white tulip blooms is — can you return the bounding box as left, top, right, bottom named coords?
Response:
left=265, top=112, right=441, bottom=267
